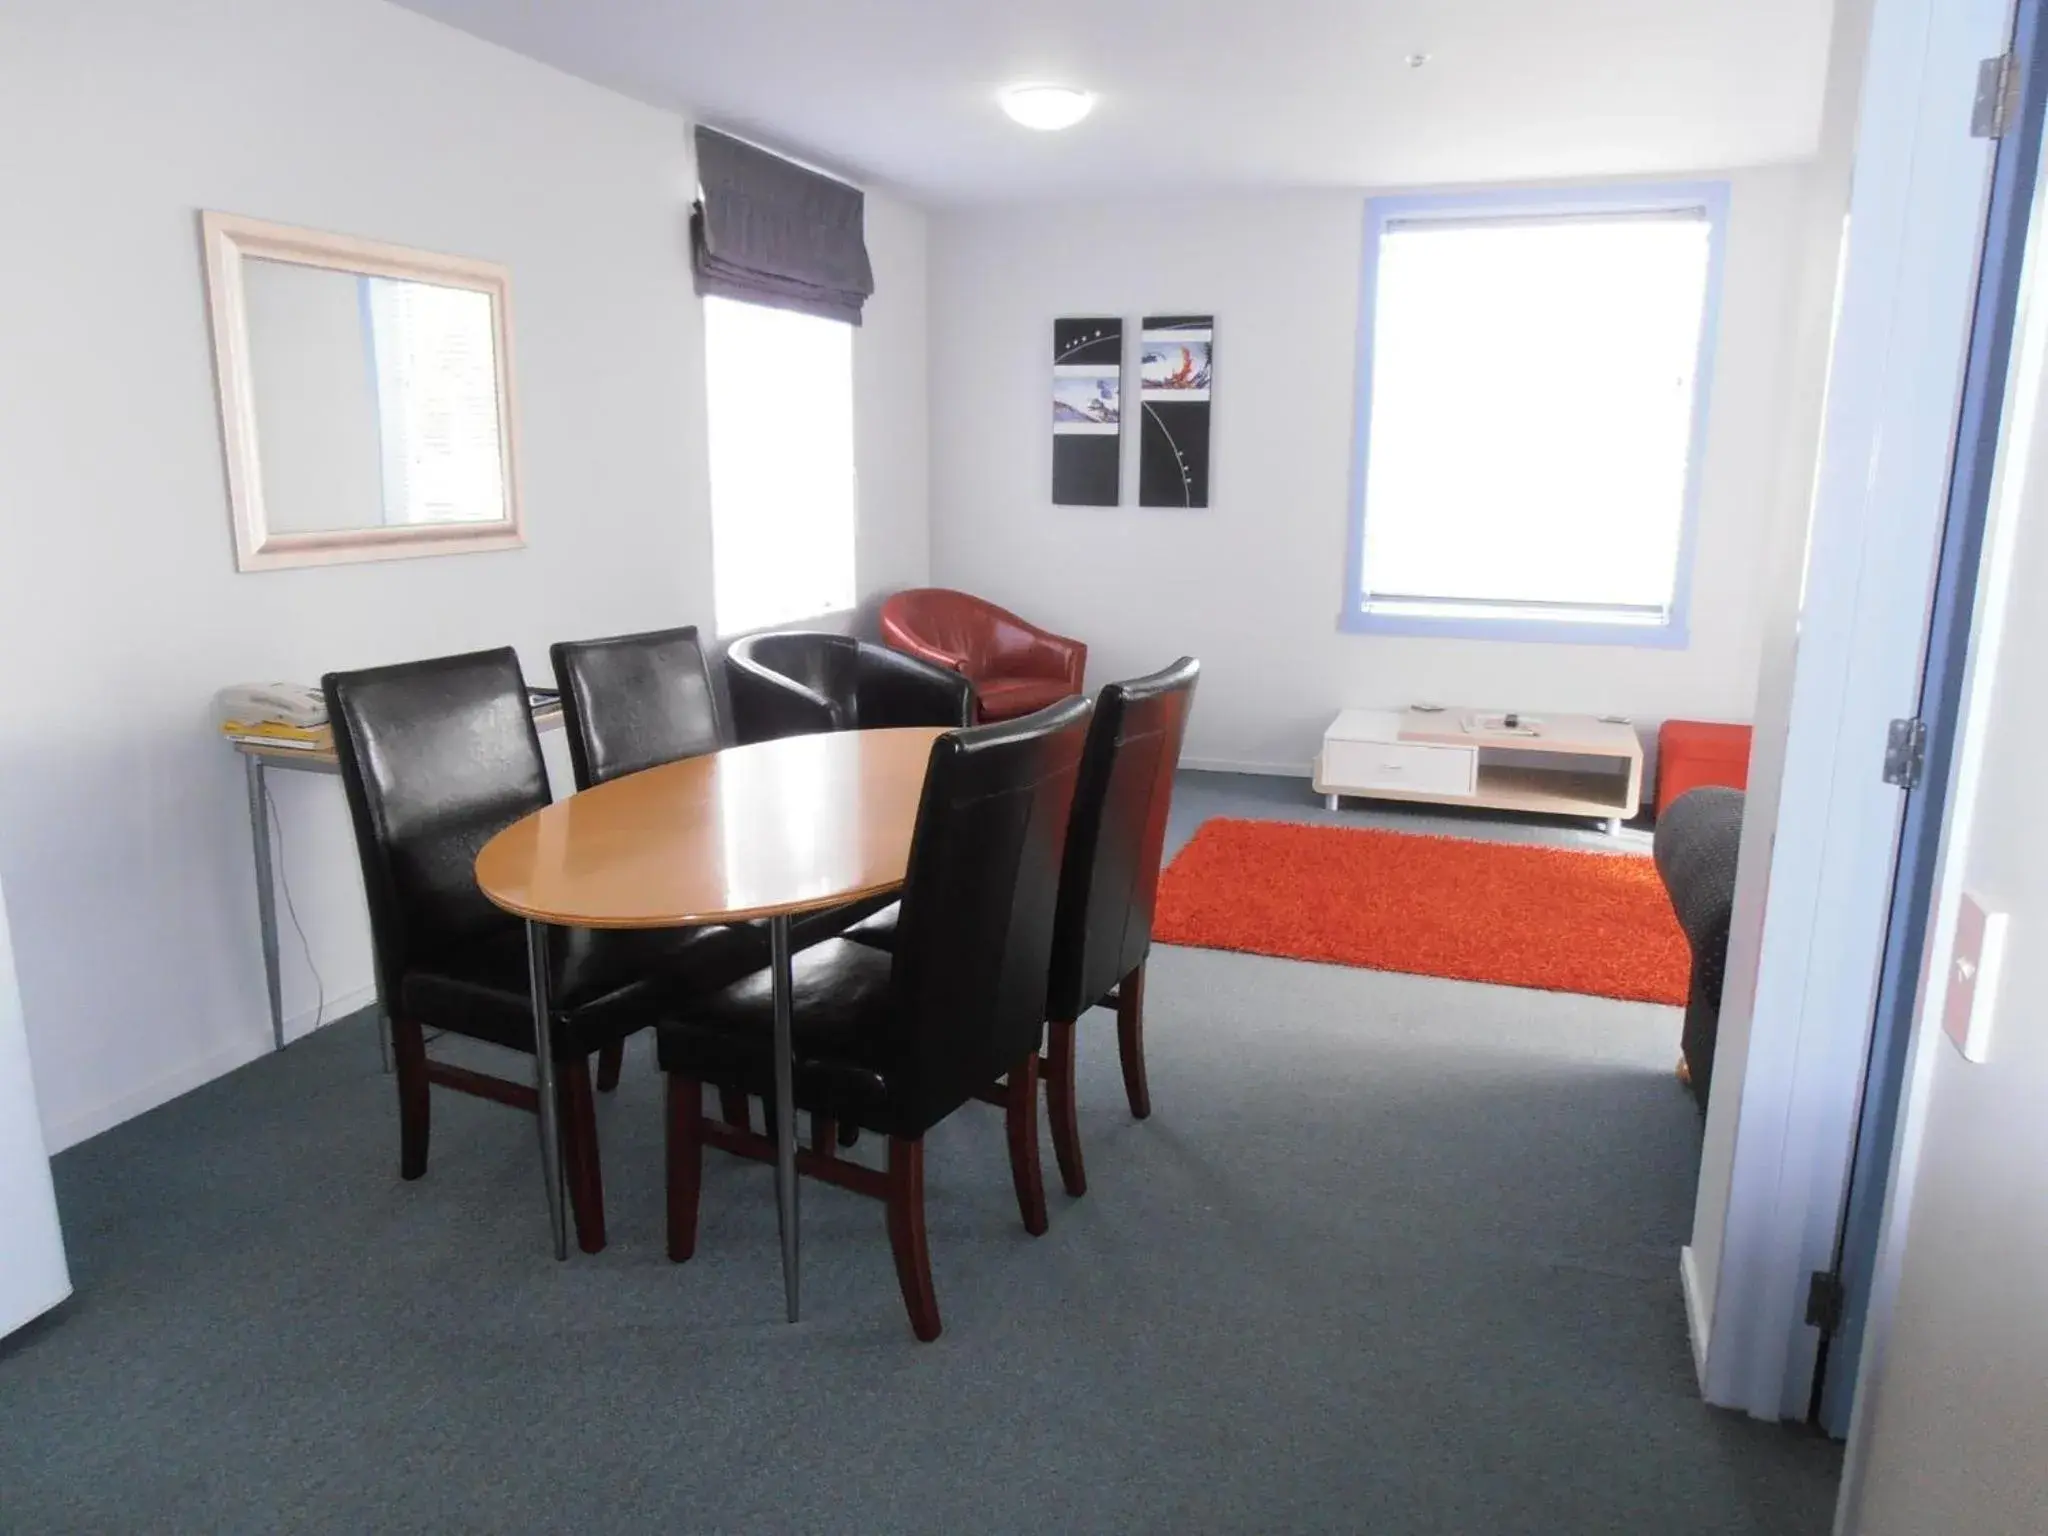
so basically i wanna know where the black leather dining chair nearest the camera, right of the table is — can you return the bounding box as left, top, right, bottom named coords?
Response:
left=657, top=698, right=1090, bottom=1341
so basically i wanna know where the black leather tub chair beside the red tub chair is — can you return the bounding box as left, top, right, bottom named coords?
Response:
left=725, top=631, right=975, bottom=741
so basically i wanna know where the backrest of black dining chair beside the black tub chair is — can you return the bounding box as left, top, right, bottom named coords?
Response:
left=549, top=625, right=729, bottom=788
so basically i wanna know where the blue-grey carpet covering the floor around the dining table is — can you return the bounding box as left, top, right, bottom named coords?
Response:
left=0, top=780, right=1839, bottom=1536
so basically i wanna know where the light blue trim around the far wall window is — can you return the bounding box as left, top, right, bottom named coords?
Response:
left=1337, top=180, right=1729, bottom=649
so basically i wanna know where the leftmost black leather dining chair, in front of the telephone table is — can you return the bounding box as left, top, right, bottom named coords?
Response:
left=322, top=647, right=696, bottom=1253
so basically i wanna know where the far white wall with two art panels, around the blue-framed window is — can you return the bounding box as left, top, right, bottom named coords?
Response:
left=932, top=168, right=1806, bottom=772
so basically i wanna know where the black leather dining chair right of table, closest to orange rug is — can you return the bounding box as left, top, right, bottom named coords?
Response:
left=1044, top=655, right=1202, bottom=1194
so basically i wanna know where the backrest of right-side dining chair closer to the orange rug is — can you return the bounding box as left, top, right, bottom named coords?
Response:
left=1047, top=655, right=1202, bottom=1020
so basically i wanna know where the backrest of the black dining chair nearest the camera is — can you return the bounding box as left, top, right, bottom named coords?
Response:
left=889, top=696, right=1090, bottom=1126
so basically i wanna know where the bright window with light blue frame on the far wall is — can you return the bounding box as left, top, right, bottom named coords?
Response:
left=1343, top=184, right=1726, bottom=645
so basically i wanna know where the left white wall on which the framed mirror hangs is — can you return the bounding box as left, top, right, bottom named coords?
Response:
left=0, top=0, right=924, bottom=1147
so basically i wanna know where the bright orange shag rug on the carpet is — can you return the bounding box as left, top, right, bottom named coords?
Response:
left=1153, top=821, right=1690, bottom=1004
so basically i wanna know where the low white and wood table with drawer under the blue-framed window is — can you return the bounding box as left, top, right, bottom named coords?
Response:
left=1315, top=709, right=1642, bottom=831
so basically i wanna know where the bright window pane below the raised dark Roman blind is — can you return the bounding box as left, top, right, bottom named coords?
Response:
left=705, top=297, right=854, bottom=635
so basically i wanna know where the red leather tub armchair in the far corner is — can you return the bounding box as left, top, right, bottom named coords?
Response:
left=881, top=586, right=1087, bottom=721
